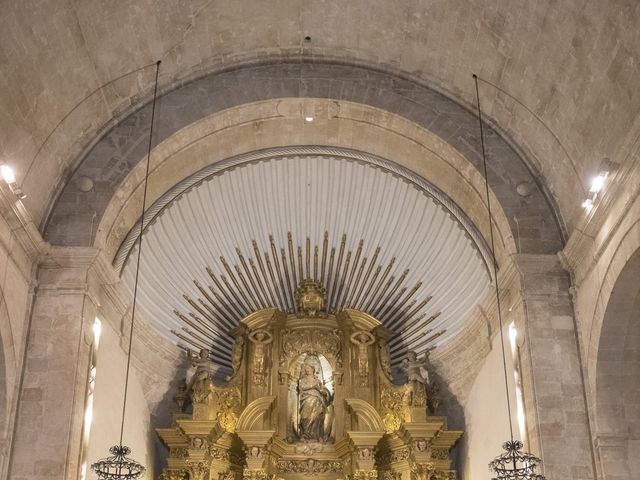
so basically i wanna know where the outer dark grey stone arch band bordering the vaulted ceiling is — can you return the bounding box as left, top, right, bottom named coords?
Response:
left=43, top=61, right=563, bottom=253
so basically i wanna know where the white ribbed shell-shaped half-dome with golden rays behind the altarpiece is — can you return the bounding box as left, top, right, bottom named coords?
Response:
left=116, top=149, right=490, bottom=364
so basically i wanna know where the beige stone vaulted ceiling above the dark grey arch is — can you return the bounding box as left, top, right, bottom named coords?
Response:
left=0, top=0, right=640, bottom=236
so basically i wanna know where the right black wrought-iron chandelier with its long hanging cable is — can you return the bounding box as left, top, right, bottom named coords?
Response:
left=473, top=74, right=545, bottom=480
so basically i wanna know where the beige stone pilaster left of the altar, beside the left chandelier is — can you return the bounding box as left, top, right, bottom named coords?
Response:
left=9, top=247, right=105, bottom=480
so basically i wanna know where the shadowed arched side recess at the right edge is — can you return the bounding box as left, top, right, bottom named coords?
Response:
left=595, top=249, right=640, bottom=480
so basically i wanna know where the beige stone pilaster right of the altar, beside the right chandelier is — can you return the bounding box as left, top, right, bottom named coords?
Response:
left=505, top=255, right=595, bottom=480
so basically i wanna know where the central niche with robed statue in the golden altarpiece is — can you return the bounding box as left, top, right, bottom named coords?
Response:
left=288, top=353, right=334, bottom=443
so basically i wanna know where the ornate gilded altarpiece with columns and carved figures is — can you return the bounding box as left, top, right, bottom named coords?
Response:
left=157, top=281, right=462, bottom=480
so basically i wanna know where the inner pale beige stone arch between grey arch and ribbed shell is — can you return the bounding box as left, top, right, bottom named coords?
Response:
left=87, top=99, right=518, bottom=274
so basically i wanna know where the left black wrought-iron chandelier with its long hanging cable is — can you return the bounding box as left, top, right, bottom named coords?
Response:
left=91, top=60, right=160, bottom=480
